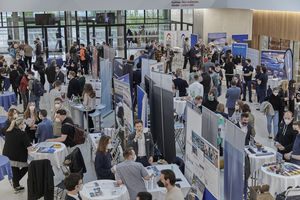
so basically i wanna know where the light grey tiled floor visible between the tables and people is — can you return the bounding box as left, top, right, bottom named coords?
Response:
left=0, top=65, right=273, bottom=200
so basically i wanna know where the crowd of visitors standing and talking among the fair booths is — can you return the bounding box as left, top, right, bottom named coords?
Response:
left=0, top=38, right=300, bottom=200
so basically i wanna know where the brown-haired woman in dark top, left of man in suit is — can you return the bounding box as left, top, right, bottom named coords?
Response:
left=95, top=135, right=115, bottom=180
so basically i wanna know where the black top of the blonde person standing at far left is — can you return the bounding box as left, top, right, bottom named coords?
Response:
left=3, top=128, right=30, bottom=162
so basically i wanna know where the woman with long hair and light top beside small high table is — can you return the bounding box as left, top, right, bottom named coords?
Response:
left=82, top=83, right=96, bottom=133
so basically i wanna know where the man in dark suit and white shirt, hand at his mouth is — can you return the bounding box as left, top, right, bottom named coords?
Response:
left=127, top=120, right=154, bottom=167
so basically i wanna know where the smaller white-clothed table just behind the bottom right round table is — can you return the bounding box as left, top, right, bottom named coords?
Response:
left=245, top=146, right=276, bottom=174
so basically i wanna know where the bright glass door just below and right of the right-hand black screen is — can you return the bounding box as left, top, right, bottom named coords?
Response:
left=107, top=25, right=127, bottom=58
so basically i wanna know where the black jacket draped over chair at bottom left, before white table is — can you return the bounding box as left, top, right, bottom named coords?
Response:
left=27, top=159, right=54, bottom=200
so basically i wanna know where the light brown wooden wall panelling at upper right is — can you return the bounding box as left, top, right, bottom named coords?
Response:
left=252, top=10, right=300, bottom=49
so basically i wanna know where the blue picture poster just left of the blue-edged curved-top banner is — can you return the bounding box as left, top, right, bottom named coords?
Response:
left=261, top=50, right=288, bottom=79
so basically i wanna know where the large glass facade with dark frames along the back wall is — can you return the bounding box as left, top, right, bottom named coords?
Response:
left=0, top=10, right=193, bottom=57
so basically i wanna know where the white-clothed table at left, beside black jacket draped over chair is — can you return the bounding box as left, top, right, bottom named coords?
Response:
left=28, top=142, right=68, bottom=183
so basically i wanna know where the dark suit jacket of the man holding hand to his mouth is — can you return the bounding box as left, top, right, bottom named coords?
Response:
left=127, top=132, right=154, bottom=159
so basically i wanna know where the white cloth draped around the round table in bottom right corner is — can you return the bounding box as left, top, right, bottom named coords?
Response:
left=261, top=163, right=300, bottom=197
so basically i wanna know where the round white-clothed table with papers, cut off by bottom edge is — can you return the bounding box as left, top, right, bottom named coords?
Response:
left=80, top=180, right=129, bottom=200
